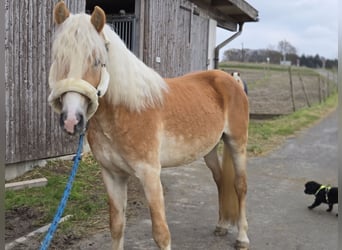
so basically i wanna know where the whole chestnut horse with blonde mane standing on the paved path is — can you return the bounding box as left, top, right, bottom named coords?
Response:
left=48, top=1, right=249, bottom=249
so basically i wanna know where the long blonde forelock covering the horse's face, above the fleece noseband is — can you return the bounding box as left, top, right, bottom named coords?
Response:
left=49, top=13, right=107, bottom=87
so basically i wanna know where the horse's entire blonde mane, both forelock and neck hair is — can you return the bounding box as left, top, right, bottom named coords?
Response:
left=49, top=13, right=167, bottom=111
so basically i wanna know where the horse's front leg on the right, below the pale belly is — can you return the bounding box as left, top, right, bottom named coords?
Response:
left=137, top=164, right=171, bottom=250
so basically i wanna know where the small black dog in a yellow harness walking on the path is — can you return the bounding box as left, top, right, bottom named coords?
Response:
left=304, top=181, right=338, bottom=216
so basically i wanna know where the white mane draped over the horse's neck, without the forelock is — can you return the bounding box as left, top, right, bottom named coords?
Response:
left=104, top=27, right=167, bottom=111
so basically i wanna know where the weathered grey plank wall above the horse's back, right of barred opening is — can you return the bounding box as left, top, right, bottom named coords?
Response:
left=143, top=0, right=209, bottom=77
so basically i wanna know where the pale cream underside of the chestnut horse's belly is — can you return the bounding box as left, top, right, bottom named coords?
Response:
left=160, top=132, right=221, bottom=167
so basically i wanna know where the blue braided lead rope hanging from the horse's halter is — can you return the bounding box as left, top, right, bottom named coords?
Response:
left=40, top=133, right=84, bottom=250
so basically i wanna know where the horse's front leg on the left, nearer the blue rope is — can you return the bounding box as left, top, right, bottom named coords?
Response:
left=102, top=168, right=128, bottom=250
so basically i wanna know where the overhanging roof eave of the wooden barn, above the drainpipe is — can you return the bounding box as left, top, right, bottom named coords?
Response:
left=190, top=0, right=259, bottom=31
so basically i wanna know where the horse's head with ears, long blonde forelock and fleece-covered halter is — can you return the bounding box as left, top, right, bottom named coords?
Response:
left=49, top=1, right=109, bottom=134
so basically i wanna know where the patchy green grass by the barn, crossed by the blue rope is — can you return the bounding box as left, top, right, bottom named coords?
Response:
left=5, top=154, right=108, bottom=236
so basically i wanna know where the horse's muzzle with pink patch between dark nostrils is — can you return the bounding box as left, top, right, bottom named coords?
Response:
left=60, top=112, right=86, bottom=135
